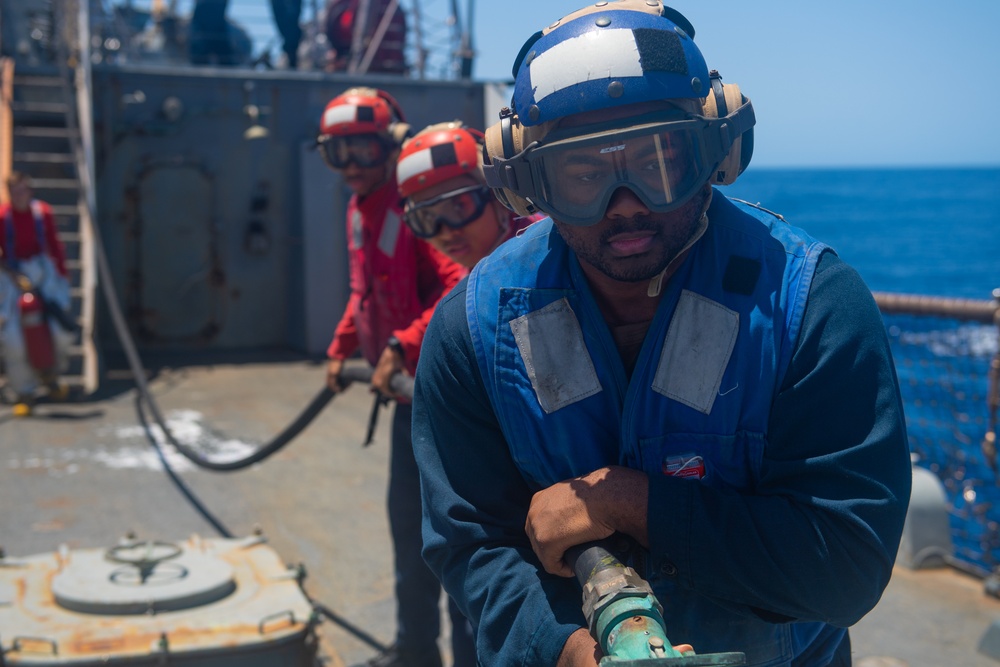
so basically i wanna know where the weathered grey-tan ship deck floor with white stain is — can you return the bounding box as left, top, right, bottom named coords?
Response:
left=0, top=355, right=1000, bottom=667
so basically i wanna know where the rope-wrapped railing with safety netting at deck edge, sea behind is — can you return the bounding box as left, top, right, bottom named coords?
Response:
left=875, top=290, right=1000, bottom=577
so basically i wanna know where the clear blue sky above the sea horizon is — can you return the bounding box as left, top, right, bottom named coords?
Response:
left=463, top=0, right=1000, bottom=166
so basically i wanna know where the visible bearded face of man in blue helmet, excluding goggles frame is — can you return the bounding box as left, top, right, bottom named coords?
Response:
left=553, top=103, right=711, bottom=282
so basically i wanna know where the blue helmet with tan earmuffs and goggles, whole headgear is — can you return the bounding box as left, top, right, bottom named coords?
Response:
left=483, top=0, right=755, bottom=226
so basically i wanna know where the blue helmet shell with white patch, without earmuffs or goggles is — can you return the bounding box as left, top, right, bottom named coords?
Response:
left=512, top=0, right=711, bottom=127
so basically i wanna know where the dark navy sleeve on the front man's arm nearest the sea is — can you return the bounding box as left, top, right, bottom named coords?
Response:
left=647, top=253, right=912, bottom=627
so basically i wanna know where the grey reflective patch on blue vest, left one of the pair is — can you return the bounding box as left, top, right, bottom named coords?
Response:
left=510, top=298, right=601, bottom=414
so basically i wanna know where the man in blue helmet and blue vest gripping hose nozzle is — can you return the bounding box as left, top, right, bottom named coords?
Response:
left=413, top=0, right=911, bottom=667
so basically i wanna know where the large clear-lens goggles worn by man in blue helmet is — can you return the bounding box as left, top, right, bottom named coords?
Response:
left=491, top=111, right=739, bottom=226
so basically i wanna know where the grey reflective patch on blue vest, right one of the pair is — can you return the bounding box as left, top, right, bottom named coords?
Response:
left=653, top=290, right=740, bottom=415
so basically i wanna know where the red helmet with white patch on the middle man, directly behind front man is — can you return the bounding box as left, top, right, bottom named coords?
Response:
left=396, top=120, right=486, bottom=197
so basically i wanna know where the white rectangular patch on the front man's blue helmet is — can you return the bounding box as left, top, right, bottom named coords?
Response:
left=530, top=28, right=642, bottom=102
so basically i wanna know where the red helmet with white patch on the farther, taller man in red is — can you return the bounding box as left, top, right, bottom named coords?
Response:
left=319, top=88, right=410, bottom=146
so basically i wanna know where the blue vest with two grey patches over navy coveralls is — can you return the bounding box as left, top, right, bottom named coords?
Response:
left=466, top=191, right=846, bottom=667
